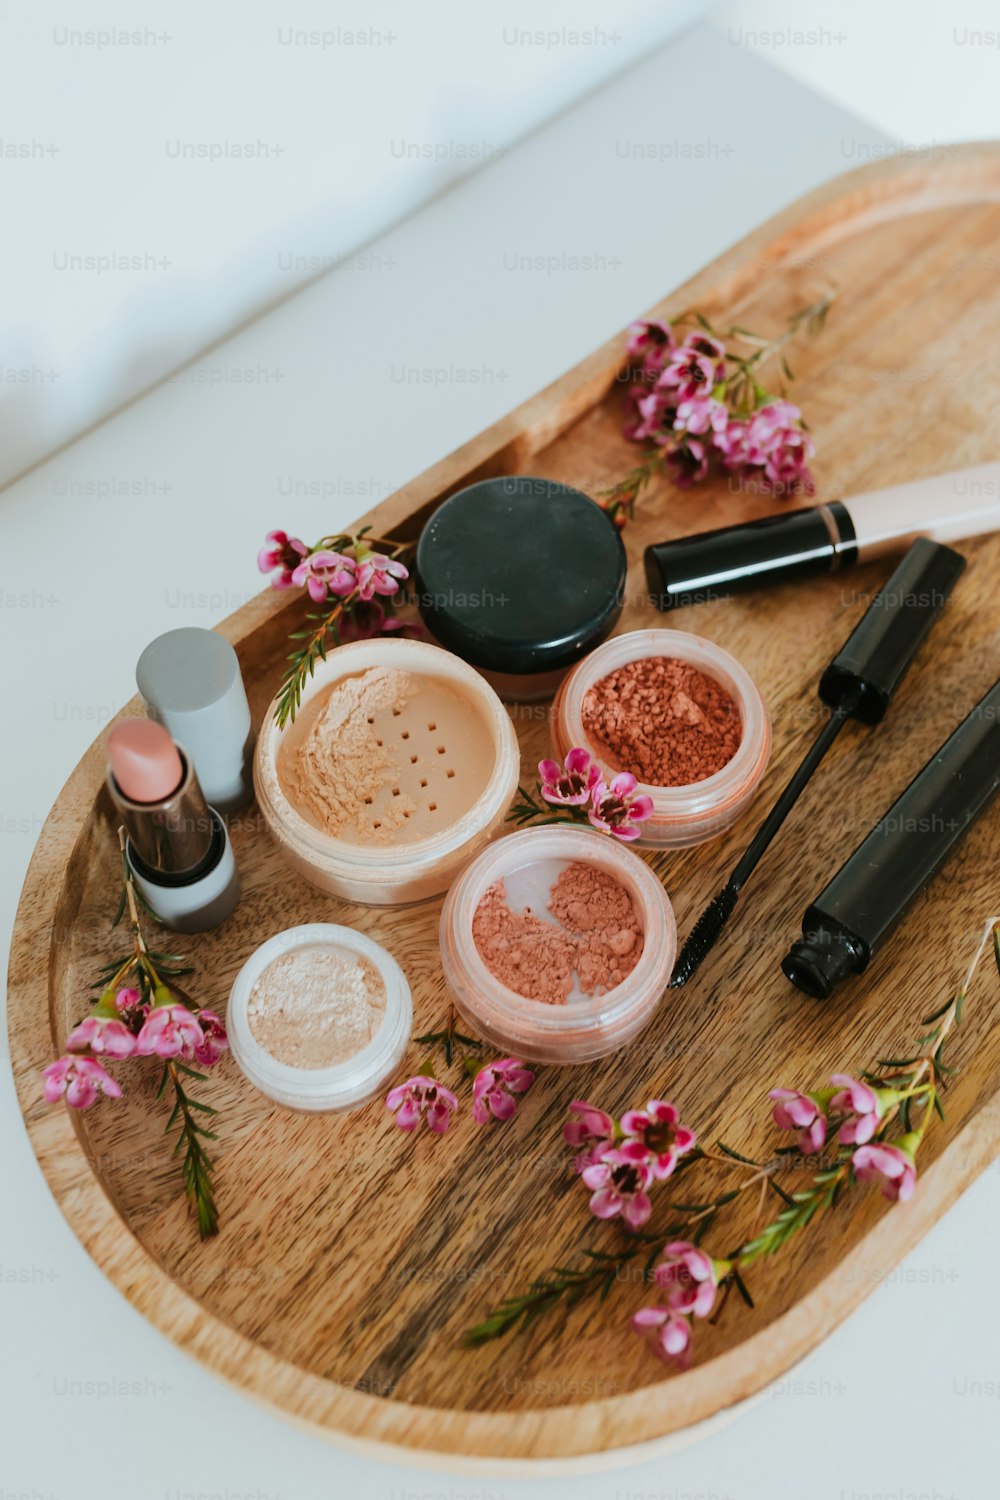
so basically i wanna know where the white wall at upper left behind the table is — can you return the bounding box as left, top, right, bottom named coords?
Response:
left=0, top=0, right=708, bottom=483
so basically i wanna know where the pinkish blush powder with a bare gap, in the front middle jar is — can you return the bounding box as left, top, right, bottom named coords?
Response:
left=472, top=860, right=643, bottom=1005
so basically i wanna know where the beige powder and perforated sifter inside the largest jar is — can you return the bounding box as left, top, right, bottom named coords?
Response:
left=277, top=666, right=495, bottom=845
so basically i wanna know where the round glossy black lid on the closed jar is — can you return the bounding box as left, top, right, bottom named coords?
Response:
left=415, top=476, right=625, bottom=674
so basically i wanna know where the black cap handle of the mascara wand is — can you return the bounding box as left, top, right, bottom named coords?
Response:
left=820, top=537, right=966, bottom=725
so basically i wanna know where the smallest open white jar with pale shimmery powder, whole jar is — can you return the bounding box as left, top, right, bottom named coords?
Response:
left=228, top=923, right=412, bottom=1112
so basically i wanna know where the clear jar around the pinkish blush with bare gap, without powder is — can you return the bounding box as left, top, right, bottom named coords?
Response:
left=441, top=827, right=678, bottom=1064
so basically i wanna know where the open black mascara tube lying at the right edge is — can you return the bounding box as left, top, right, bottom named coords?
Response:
left=781, top=681, right=1000, bottom=1001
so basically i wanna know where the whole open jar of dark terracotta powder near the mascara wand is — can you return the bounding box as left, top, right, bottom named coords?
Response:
left=552, top=630, right=771, bottom=849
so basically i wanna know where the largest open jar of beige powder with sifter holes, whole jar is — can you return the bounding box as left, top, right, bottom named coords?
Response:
left=253, top=638, right=520, bottom=906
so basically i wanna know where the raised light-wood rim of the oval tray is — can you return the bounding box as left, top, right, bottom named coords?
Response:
left=7, top=141, right=1000, bottom=1476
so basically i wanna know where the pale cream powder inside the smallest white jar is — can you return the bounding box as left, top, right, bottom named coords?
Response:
left=247, top=948, right=385, bottom=1068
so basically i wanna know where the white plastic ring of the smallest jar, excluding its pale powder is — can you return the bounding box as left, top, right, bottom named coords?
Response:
left=226, top=923, right=414, bottom=1115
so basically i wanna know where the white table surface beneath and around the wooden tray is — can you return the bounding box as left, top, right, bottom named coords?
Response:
left=0, top=29, right=1000, bottom=1500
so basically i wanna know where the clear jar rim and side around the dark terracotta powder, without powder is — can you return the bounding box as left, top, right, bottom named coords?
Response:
left=552, top=630, right=771, bottom=849
